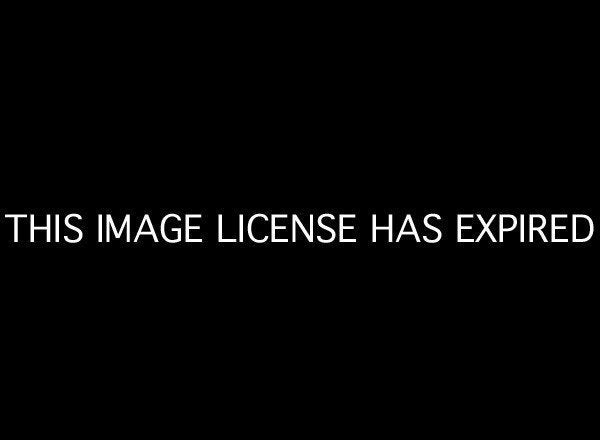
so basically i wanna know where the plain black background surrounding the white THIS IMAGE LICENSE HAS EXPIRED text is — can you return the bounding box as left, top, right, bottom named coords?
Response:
left=1, top=5, right=598, bottom=433
